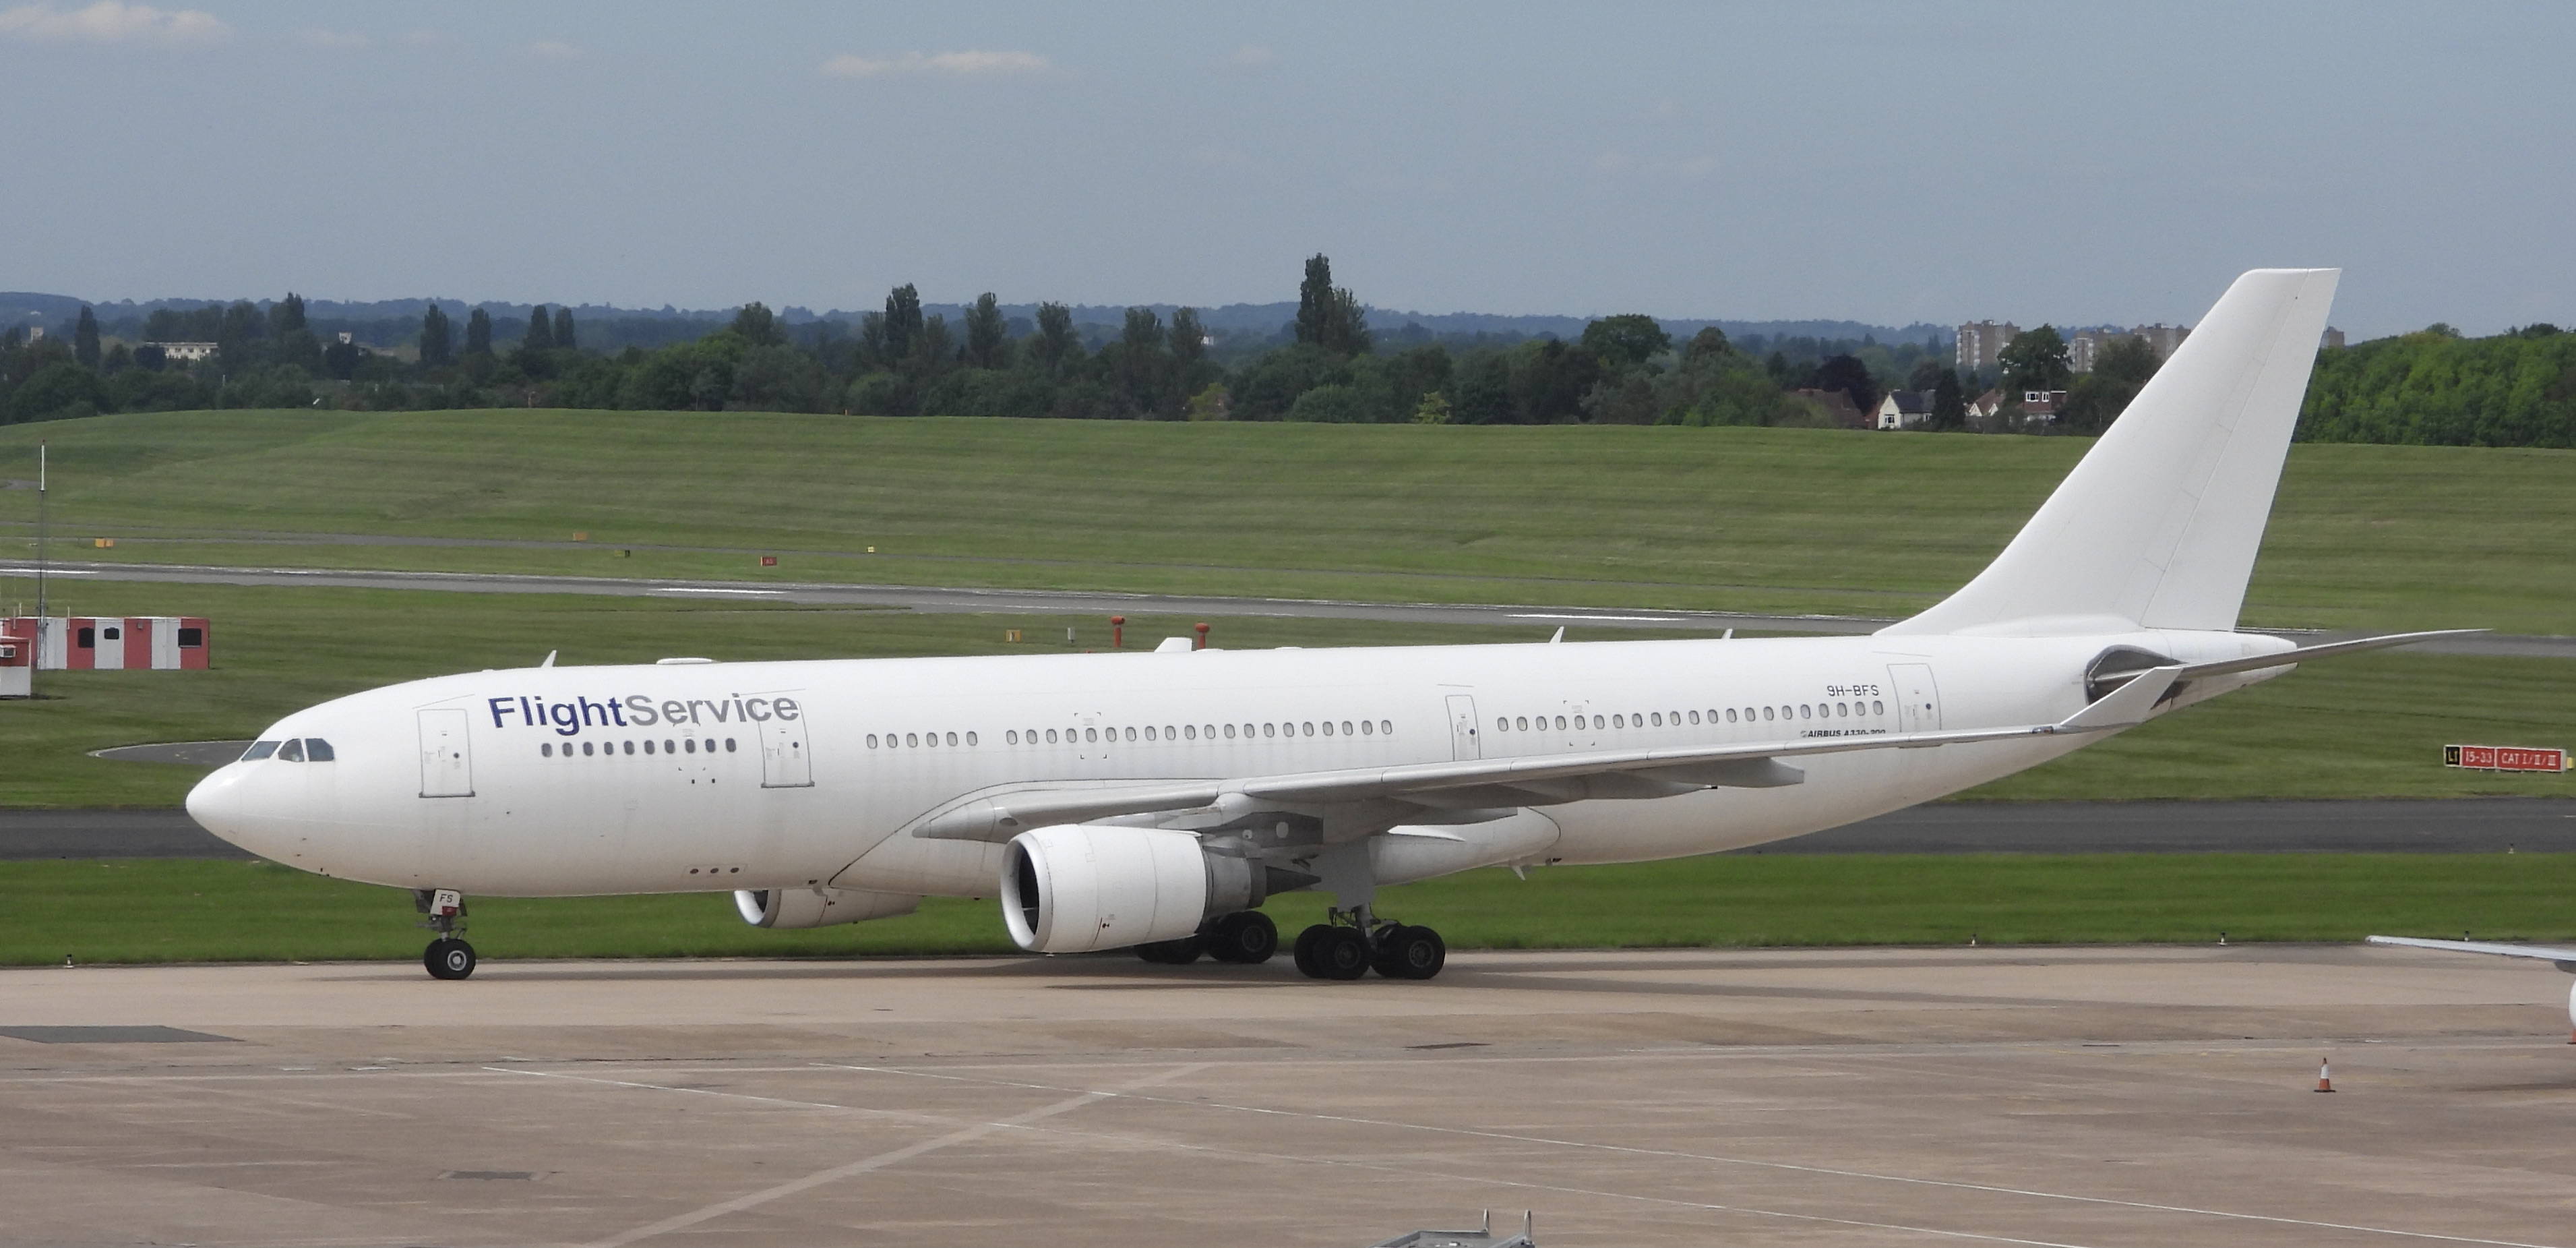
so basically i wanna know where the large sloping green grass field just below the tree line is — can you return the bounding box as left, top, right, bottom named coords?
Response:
left=0, top=410, right=2576, bottom=634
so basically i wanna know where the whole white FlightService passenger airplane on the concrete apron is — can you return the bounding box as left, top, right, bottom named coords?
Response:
left=188, top=268, right=2473, bottom=980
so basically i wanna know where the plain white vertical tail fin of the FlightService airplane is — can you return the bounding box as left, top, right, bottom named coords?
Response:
left=1883, top=268, right=2341, bottom=634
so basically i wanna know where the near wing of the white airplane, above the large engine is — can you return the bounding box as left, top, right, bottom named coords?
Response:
left=912, top=663, right=2184, bottom=841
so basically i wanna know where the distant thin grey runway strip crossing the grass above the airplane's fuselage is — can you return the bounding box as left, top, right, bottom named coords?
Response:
left=20, top=560, right=2576, bottom=647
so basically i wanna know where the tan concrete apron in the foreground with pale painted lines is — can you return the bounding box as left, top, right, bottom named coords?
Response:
left=0, top=947, right=2576, bottom=1248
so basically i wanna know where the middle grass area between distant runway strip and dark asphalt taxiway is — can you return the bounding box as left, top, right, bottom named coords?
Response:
left=0, top=580, right=2576, bottom=807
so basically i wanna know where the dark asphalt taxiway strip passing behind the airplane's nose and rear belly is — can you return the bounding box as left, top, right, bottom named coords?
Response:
left=25, top=794, right=2576, bottom=861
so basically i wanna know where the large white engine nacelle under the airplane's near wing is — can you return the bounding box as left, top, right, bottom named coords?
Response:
left=1002, top=823, right=1272, bottom=954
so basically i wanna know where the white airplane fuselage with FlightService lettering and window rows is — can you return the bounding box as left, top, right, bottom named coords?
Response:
left=191, top=632, right=2288, bottom=897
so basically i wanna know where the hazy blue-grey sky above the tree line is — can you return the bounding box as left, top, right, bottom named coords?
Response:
left=0, top=0, right=2576, bottom=338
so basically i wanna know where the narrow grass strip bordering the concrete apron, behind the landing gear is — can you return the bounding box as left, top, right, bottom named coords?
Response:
left=0, top=854, right=2576, bottom=964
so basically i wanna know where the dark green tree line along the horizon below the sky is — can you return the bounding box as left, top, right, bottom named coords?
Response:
left=0, top=256, right=2571, bottom=446
